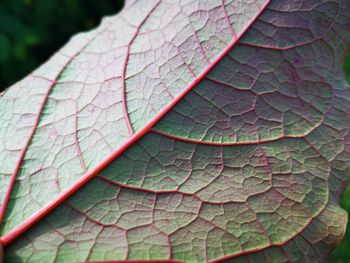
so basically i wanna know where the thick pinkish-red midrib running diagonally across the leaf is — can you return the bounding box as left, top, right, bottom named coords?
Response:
left=0, top=0, right=271, bottom=246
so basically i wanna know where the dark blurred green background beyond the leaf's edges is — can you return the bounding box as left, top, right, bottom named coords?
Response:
left=0, top=0, right=350, bottom=263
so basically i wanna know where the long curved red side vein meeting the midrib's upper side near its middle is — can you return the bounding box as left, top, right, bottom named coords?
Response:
left=122, top=0, right=160, bottom=135
